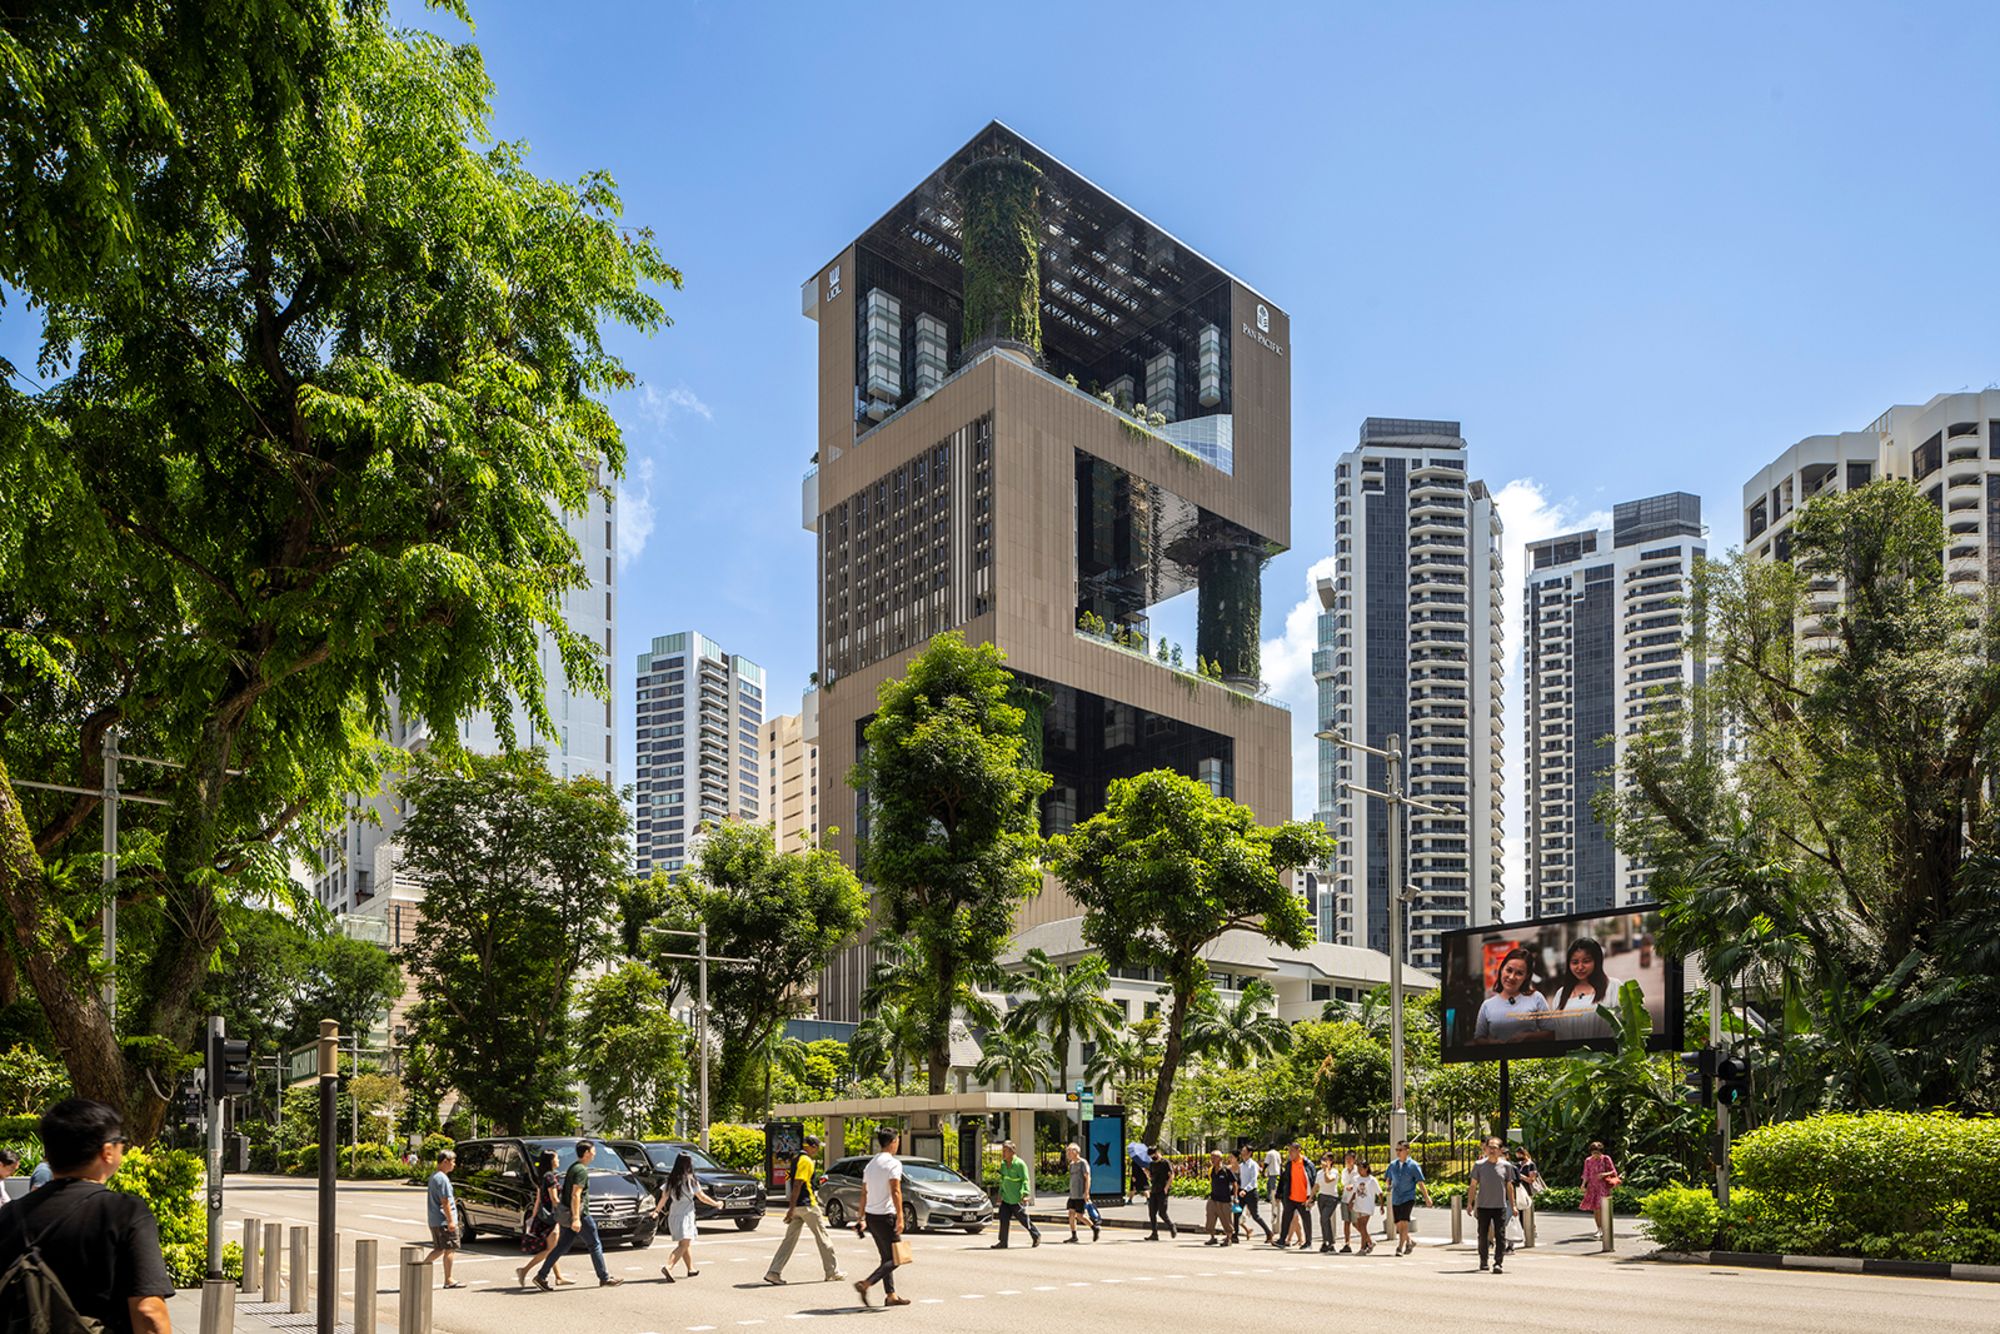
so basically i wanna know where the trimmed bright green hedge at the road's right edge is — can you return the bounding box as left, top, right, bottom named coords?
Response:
left=1642, top=1112, right=2000, bottom=1264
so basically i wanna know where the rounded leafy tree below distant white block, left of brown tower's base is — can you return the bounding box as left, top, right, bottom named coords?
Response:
left=660, top=820, right=868, bottom=1110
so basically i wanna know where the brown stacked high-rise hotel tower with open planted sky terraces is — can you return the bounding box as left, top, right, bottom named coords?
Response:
left=802, top=122, right=1292, bottom=1020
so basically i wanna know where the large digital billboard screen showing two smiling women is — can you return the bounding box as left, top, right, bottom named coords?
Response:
left=1438, top=904, right=1686, bottom=1060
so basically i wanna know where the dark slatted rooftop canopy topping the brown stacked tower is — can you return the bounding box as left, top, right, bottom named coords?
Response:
left=832, top=120, right=1272, bottom=386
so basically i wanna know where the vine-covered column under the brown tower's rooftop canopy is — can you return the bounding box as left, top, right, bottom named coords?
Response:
left=958, top=156, right=1042, bottom=356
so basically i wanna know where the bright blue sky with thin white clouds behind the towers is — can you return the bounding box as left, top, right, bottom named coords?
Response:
left=442, top=0, right=2000, bottom=904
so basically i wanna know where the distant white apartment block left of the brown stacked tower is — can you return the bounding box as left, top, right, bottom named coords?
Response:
left=634, top=630, right=764, bottom=876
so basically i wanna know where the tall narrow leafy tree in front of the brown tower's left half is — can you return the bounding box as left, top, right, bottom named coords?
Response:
left=848, top=630, right=1048, bottom=1094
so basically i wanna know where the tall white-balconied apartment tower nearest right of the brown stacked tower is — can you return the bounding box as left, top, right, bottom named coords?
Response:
left=1312, top=418, right=1504, bottom=970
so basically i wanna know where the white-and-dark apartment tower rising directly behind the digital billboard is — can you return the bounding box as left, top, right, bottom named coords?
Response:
left=1520, top=492, right=1708, bottom=918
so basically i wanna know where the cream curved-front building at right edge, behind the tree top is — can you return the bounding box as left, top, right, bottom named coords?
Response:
left=1744, top=390, right=2000, bottom=652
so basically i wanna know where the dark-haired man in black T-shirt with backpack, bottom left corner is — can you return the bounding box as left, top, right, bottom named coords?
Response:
left=0, top=1098, right=174, bottom=1334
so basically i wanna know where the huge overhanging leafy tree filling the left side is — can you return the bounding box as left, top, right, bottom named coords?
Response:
left=0, top=0, right=678, bottom=1140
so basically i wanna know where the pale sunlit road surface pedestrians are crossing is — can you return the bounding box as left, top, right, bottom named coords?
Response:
left=207, top=1178, right=2000, bottom=1334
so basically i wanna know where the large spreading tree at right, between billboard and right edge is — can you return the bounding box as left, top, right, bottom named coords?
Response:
left=1606, top=480, right=2000, bottom=1114
